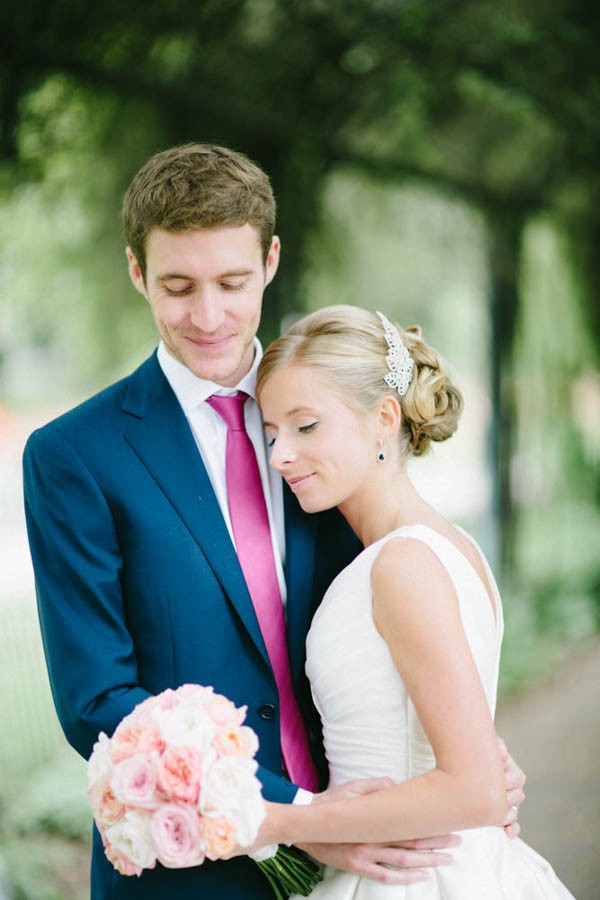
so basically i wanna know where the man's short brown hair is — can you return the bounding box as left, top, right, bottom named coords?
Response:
left=123, top=144, right=275, bottom=278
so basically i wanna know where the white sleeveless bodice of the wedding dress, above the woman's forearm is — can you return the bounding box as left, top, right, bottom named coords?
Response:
left=306, top=525, right=502, bottom=786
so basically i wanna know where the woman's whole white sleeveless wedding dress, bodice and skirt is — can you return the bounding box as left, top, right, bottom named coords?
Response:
left=298, top=525, right=573, bottom=900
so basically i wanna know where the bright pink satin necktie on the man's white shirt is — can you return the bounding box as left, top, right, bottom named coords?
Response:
left=207, top=391, right=318, bottom=791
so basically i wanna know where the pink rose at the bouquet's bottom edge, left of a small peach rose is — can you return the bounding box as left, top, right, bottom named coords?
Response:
left=150, top=803, right=205, bottom=869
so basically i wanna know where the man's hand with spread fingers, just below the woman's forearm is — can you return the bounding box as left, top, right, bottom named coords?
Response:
left=300, top=834, right=461, bottom=884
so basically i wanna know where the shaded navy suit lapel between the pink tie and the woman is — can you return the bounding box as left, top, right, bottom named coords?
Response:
left=283, top=484, right=318, bottom=679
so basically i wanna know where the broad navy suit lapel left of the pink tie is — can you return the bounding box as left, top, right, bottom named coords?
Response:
left=123, top=355, right=269, bottom=664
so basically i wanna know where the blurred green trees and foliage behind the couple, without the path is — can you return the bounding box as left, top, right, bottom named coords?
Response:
left=0, top=0, right=600, bottom=900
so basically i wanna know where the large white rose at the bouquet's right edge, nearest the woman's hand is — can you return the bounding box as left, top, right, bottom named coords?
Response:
left=198, top=756, right=265, bottom=847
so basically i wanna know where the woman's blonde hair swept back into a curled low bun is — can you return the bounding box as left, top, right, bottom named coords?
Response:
left=257, top=305, right=463, bottom=457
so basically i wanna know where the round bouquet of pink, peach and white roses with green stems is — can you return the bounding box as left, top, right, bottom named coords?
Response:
left=88, top=684, right=320, bottom=900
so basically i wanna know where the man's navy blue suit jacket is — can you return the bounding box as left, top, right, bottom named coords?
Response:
left=24, top=354, right=358, bottom=900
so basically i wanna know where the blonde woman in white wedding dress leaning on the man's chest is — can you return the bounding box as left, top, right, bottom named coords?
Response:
left=257, top=306, right=571, bottom=900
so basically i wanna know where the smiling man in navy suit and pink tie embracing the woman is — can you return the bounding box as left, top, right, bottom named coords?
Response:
left=24, top=145, right=518, bottom=900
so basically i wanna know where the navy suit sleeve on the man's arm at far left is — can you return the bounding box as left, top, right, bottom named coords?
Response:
left=23, top=427, right=149, bottom=758
